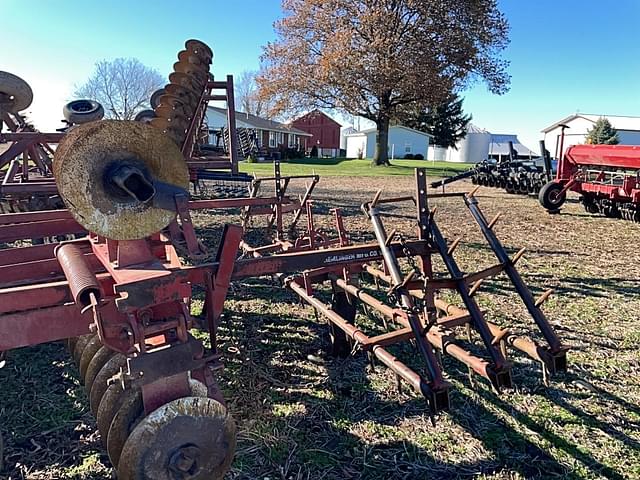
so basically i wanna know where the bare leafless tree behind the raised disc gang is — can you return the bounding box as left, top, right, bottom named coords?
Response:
left=74, top=58, right=166, bottom=120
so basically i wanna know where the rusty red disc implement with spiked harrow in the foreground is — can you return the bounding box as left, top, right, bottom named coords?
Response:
left=0, top=42, right=567, bottom=480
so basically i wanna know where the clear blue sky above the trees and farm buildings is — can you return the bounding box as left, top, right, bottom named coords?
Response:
left=0, top=0, right=640, bottom=150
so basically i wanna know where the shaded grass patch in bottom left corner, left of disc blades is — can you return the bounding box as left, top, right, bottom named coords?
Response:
left=0, top=343, right=110, bottom=479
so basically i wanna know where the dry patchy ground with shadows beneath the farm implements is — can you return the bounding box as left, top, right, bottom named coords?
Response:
left=0, top=177, right=640, bottom=480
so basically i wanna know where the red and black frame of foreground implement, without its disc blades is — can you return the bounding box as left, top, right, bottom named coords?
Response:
left=0, top=164, right=567, bottom=462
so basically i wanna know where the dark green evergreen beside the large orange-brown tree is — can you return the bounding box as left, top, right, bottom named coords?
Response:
left=398, top=94, right=471, bottom=148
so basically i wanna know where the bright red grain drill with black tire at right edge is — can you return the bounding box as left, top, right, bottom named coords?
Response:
left=539, top=145, right=640, bottom=222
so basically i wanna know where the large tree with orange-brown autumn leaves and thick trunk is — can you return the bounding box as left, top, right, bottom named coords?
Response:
left=257, top=0, right=509, bottom=165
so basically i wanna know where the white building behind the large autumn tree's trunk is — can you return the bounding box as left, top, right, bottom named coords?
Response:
left=344, top=125, right=431, bottom=158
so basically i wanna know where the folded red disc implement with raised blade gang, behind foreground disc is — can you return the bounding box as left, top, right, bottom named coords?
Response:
left=0, top=40, right=251, bottom=213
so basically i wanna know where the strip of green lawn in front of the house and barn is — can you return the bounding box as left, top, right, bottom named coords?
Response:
left=240, top=158, right=470, bottom=177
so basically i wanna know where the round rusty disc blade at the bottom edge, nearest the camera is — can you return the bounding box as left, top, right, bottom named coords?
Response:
left=118, top=397, right=236, bottom=480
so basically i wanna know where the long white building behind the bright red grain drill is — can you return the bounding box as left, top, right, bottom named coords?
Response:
left=542, top=113, right=640, bottom=158
